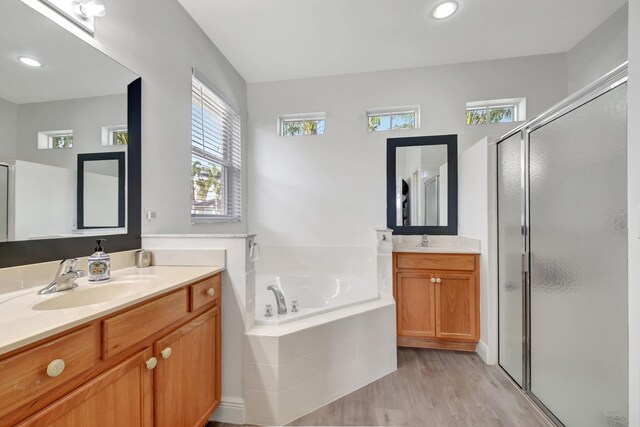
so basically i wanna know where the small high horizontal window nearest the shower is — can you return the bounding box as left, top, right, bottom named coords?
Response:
left=466, top=98, right=526, bottom=125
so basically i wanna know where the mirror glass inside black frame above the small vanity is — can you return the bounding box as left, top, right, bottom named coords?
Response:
left=396, top=144, right=448, bottom=226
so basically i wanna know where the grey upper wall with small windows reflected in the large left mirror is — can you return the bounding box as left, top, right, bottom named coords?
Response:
left=17, top=94, right=127, bottom=171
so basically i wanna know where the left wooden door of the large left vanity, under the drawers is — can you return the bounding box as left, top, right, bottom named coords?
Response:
left=19, top=348, right=153, bottom=427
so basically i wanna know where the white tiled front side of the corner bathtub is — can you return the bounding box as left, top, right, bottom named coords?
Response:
left=245, top=295, right=397, bottom=425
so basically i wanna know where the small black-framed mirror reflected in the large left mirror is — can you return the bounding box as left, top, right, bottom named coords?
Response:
left=77, top=151, right=126, bottom=230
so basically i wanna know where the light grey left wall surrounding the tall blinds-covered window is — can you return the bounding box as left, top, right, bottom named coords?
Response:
left=22, top=0, right=247, bottom=233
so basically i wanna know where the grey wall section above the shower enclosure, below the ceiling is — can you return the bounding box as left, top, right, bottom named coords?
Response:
left=567, top=5, right=628, bottom=93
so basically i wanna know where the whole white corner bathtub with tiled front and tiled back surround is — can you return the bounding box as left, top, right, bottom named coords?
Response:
left=244, top=242, right=397, bottom=425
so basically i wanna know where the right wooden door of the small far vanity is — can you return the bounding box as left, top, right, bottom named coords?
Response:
left=435, top=273, right=478, bottom=341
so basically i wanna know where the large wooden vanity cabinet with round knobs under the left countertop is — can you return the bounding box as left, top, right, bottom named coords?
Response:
left=0, top=273, right=222, bottom=427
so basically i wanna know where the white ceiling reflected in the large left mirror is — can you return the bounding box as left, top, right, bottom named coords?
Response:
left=0, top=1, right=137, bottom=104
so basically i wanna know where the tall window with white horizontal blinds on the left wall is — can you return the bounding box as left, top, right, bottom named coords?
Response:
left=191, top=76, right=242, bottom=222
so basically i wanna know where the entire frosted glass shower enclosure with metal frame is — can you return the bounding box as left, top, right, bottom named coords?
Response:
left=497, top=64, right=628, bottom=427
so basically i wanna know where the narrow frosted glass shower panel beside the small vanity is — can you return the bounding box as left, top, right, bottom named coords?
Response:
left=498, top=133, right=524, bottom=387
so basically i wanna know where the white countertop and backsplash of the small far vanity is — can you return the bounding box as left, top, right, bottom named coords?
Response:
left=393, top=235, right=481, bottom=254
